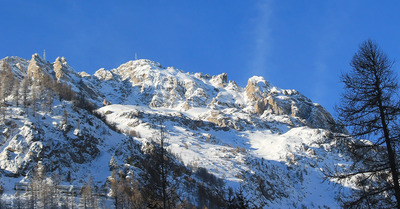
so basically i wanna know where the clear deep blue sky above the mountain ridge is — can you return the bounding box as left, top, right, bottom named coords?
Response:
left=0, top=0, right=400, bottom=115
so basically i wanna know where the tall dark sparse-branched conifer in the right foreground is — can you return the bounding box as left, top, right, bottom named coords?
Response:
left=332, top=40, right=400, bottom=208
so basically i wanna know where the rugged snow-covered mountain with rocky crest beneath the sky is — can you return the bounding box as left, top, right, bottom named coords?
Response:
left=0, top=54, right=351, bottom=208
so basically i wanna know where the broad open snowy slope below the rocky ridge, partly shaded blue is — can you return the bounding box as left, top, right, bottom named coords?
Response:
left=99, top=105, right=349, bottom=208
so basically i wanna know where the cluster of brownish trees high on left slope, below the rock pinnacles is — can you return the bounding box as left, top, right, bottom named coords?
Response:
left=0, top=60, right=88, bottom=121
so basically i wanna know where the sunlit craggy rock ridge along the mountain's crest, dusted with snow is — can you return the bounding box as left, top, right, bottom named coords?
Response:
left=3, top=54, right=343, bottom=134
